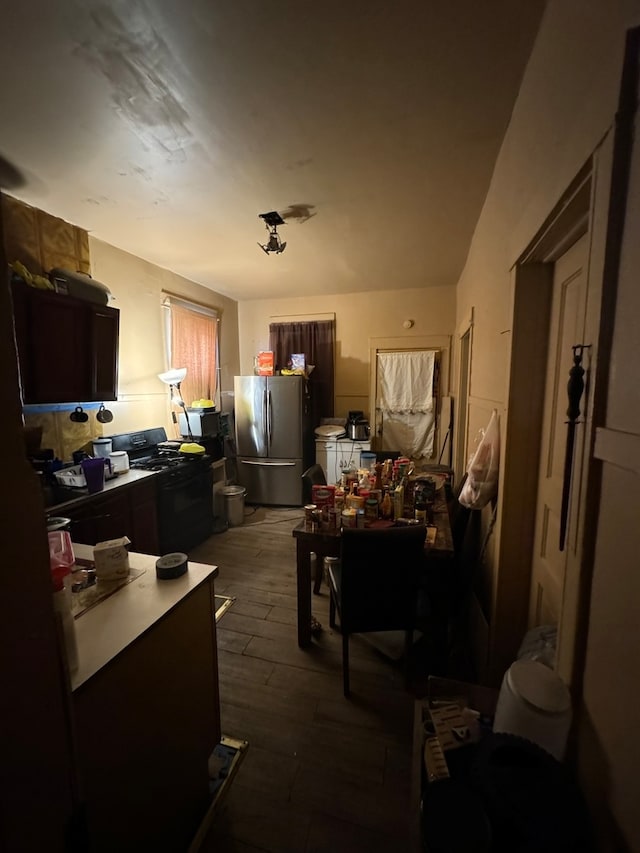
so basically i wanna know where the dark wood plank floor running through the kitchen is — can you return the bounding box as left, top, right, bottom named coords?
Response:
left=190, top=507, right=470, bottom=853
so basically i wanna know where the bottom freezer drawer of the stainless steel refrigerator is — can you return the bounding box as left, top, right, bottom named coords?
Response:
left=238, top=456, right=303, bottom=506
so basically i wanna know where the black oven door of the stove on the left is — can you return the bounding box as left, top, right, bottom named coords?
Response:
left=158, top=466, right=213, bottom=554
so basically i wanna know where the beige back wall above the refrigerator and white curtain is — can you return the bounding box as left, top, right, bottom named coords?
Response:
left=239, top=287, right=455, bottom=417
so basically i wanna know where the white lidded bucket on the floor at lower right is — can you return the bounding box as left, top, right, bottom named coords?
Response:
left=493, top=660, right=571, bottom=761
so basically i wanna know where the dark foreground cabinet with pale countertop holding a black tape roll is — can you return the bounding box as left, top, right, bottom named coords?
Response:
left=72, top=547, right=221, bottom=853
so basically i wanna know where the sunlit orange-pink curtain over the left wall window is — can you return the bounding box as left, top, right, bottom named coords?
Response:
left=170, top=301, right=218, bottom=406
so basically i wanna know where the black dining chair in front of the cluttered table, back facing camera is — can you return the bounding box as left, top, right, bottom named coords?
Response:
left=329, top=524, right=426, bottom=698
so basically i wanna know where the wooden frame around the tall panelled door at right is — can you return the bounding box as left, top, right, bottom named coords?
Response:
left=487, top=145, right=613, bottom=684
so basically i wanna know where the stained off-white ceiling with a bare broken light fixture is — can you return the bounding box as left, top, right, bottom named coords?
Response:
left=0, top=0, right=544, bottom=299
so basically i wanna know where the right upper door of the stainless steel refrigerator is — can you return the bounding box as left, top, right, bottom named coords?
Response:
left=264, top=376, right=305, bottom=459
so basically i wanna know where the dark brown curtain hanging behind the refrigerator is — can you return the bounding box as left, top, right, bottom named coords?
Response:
left=269, top=320, right=335, bottom=427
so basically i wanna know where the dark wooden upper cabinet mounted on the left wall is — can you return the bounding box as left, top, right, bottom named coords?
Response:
left=12, top=281, right=120, bottom=405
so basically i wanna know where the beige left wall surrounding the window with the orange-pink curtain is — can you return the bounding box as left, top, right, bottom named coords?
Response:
left=89, top=237, right=239, bottom=436
